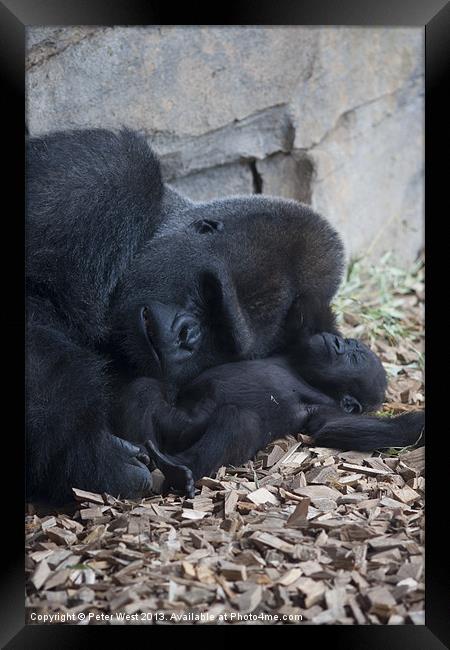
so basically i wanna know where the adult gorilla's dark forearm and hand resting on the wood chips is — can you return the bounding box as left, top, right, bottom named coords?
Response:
left=26, top=304, right=151, bottom=504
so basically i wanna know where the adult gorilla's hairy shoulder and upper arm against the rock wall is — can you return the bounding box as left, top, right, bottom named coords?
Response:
left=26, top=129, right=176, bottom=343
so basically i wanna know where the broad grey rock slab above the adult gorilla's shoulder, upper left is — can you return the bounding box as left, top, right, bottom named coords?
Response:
left=26, top=26, right=317, bottom=137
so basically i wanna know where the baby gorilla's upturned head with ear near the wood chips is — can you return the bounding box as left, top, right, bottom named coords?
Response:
left=300, top=333, right=387, bottom=413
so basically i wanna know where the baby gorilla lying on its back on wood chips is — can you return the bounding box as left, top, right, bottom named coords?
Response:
left=117, top=333, right=423, bottom=496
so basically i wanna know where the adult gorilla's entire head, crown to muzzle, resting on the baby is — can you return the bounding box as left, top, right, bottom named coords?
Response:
left=112, top=197, right=341, bottom=386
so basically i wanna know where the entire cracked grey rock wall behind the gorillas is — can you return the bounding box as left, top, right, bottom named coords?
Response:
left=27, top=26, right=424, bottom=265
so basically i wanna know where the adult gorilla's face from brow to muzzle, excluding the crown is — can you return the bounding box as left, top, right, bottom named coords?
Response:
left=113, top=230, right=292, bottom=385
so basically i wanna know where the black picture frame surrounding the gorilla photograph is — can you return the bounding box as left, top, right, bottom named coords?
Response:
left=0, top=0, right=450, bottom=650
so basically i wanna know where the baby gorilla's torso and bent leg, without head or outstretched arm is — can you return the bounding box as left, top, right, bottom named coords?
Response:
left=143, top=358, right=334, bottom=493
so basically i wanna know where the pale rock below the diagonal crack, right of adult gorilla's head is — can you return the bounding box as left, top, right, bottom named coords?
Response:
left=309, top=71, right=424, bottom=266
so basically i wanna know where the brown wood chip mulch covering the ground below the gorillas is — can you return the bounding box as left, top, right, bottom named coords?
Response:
left=26, top=435, right=425, bottom=624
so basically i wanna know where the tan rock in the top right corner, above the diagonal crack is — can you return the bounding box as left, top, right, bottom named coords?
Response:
left=291, top=28, right=424, bottom=149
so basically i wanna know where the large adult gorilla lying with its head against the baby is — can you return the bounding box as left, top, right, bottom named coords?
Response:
left=27, top=130, right=343, bottom=502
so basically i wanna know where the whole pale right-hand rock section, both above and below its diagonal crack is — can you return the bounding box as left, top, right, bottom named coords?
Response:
left=292, top=28, right=424, bottom=266
